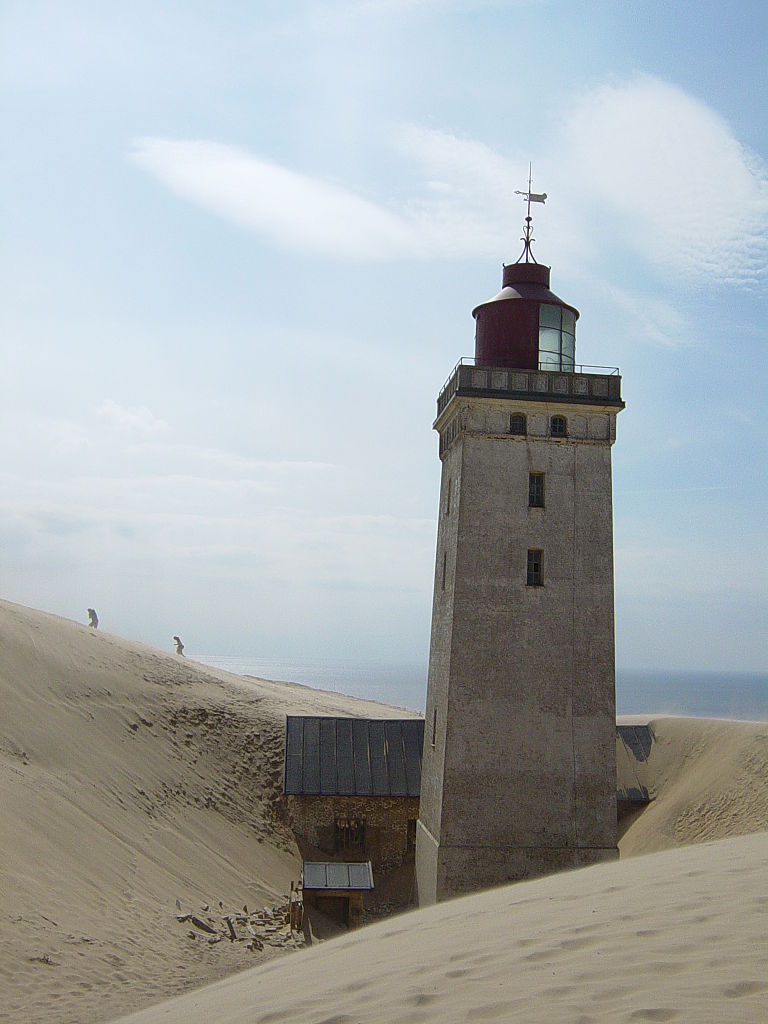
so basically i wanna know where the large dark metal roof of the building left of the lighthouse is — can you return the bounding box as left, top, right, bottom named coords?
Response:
left=283, top=715, right=424, bottom=797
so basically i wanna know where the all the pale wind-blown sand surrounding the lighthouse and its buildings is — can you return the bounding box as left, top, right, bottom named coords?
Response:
left=0, top=602, right=768, bottom=1024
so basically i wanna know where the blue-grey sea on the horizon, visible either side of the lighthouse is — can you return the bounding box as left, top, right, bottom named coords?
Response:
left=189, top=654, right=768, bottom=721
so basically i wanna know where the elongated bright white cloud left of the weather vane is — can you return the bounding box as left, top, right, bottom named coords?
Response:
left=131, top=133, right=521, bottom=261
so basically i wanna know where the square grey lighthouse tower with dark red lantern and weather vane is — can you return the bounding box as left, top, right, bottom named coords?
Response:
left=416, top=190, right=624, bottom=905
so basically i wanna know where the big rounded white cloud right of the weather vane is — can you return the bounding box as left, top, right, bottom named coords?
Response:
left=560, top=77, right=768, bottom=284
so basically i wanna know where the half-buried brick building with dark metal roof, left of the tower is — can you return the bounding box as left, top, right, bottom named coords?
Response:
left=284, top=716, right=424, bottom=872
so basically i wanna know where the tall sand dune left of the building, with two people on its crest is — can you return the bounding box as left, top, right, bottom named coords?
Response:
left=0, top=602, right=417, bottom=1024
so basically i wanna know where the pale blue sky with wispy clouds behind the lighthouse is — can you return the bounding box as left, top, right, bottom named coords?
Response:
left=0, top=0, right=768, bottom=671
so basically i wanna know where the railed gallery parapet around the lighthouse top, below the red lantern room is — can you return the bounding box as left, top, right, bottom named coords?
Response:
left=437, top=357, right=624, bottom=417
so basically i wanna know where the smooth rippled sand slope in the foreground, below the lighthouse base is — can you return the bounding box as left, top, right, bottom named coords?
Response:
left=114, top=833, right=768, bottom=1024
